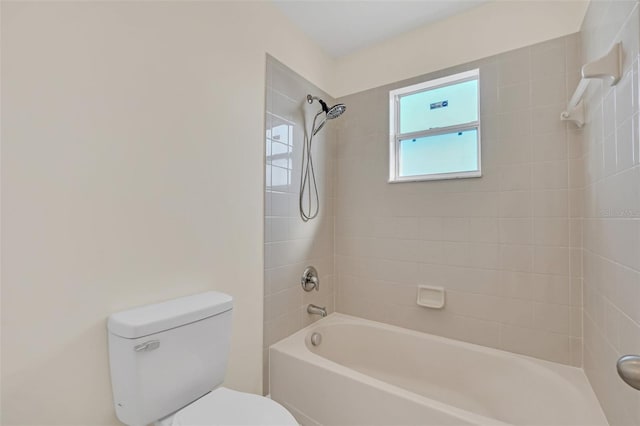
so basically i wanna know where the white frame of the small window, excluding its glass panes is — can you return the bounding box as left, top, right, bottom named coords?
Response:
left=388, top=68, right=482, bottom=183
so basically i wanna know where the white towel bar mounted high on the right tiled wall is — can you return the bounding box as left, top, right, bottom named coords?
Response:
left=560, top=43, right=622, bottom=127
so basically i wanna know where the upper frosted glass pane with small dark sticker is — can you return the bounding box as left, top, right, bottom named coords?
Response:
left=400, top=80, right=478, bottom=133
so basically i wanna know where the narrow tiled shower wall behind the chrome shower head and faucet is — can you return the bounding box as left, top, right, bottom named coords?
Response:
left=263, top=57, right=337, bottom=394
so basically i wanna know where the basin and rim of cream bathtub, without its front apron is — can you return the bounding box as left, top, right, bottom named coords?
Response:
left=273, top=313, right=607, bottom=425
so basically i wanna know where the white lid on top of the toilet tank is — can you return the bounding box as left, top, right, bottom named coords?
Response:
left=107, top=291, right=233, bottom=339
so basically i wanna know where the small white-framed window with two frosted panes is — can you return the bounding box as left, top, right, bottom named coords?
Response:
left=389, top=69, right=481, bottom=182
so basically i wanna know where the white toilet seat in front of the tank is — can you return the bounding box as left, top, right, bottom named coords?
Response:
left=171, top=387, right=298, bottom=426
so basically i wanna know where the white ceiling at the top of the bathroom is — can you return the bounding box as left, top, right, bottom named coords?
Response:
left=272, top=0, right=487, bottom=57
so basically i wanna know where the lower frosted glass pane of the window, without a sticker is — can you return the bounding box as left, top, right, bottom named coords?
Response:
left=399, top=129, right=478, bottom=176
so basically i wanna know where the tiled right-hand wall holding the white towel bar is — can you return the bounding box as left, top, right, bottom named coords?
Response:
left=581, top=0, right=640, bottom=425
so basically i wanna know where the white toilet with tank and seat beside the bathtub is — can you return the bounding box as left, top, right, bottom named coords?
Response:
left=108, top=291, right=298, bottom=426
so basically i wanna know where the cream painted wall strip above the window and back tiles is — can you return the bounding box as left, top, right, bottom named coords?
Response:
left=329, top=1, right=588, bottom=97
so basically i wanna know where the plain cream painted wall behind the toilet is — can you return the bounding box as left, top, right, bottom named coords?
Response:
left=2, top=2, right=332, bottom=425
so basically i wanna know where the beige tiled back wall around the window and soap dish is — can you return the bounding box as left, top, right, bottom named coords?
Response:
left=335, top=35, right=582, bottom=365
